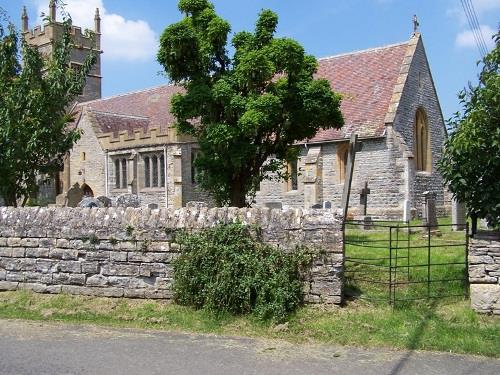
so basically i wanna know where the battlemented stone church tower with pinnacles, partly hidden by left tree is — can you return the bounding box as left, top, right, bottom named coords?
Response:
left=21, top=0, right=102, bottom=103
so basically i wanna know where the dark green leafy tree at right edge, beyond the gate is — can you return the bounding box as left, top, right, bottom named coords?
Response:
left=439, top=32, right=500, bottom=227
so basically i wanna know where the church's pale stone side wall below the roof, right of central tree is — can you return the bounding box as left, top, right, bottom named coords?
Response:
left=256, top=137, right=405, bottom=218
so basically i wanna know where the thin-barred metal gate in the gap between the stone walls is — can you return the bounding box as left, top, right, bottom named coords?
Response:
left=344, top=221, right=469, bottom=306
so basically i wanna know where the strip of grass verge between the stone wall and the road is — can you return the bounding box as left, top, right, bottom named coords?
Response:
left=0, top=291, right=500, bottom=358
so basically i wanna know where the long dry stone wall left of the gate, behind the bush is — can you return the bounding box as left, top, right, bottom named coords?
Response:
left=0, top=207, right=343, bottom=304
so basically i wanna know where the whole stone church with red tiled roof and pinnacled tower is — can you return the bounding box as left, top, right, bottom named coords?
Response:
left=23, top=2, right=450, bottom=218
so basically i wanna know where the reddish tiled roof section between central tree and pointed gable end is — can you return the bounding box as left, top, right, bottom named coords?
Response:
left=309, top=43, right=408, bottom=142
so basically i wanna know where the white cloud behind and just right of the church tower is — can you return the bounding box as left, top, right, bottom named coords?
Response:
left=35, top=0, right=158, bottom=61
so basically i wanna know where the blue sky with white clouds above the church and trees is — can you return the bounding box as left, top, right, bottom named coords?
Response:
left=0, top=0, right=500, bottom=118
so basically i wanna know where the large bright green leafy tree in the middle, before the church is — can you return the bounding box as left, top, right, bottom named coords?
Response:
left=158, top=0, right=343, bottom=207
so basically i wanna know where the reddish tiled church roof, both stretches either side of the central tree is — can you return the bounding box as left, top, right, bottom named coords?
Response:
left=79, top=38, right=408, bottom=142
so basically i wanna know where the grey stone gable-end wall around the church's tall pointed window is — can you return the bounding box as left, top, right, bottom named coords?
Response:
left=394, top=39, right=451, bottom=215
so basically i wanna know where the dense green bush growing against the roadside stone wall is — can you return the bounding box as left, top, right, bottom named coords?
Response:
left=173, top=223, right=311, bottom=321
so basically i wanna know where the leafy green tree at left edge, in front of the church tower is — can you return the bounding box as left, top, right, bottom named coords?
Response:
left=0, top=8, right=95, bottom=206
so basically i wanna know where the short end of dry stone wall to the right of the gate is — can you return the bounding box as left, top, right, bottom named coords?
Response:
left=469, top=238, right=500, bottom=315
